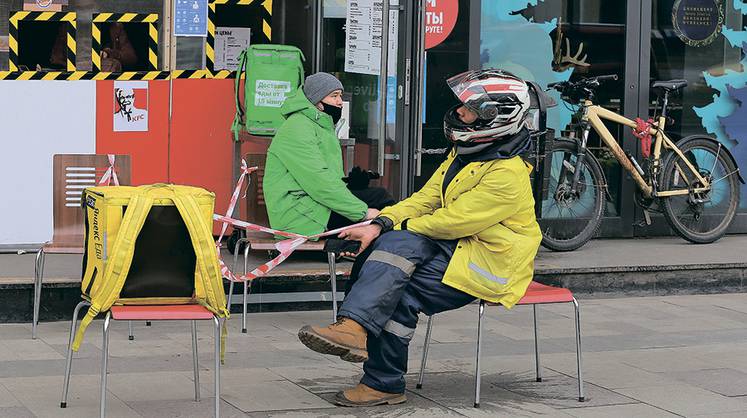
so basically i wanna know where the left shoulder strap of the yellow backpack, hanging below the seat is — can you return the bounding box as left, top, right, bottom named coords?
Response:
left=72, top=191, right=153, bottom=351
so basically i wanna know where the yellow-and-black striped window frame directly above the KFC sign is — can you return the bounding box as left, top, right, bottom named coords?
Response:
left=91, top=13, right=158, bottom=71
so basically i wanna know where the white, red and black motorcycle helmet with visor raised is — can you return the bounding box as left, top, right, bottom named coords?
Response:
left=444, top=69, right=531, bottom=147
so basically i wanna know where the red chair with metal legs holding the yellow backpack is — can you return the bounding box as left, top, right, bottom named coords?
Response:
left=60, top=301, right=221, bottom=418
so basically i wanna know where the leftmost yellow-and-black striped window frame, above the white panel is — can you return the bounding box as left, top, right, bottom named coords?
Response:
left=8, top=11, right=77, bottom=71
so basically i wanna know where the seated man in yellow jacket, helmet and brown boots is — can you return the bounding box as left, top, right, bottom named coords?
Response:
left=299, top=70, right=542, bottom=406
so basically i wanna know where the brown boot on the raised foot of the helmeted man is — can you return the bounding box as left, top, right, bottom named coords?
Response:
left=298, top=318, right=368, bottom=363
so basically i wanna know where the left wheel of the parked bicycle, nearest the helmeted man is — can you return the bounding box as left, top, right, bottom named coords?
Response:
left=536, top=141, right=604, bottom=251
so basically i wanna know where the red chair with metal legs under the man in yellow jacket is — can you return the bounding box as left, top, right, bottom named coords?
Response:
left=417, top=281, right=586, bottom=408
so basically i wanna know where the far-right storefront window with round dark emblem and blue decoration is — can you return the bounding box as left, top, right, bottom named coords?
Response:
left=649, top=0, right=747, bottom=212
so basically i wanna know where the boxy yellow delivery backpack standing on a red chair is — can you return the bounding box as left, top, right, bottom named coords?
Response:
left=73, top=184, right=229, bottom=351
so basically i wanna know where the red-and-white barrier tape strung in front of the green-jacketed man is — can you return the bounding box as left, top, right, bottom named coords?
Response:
left=213, top=160, right=371, bottom=282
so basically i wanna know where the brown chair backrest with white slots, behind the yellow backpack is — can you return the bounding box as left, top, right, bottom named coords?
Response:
left=51, top=154, right=130, bottom=248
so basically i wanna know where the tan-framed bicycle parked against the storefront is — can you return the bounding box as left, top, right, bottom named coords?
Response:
left=536, top=75, right=744, bottom=251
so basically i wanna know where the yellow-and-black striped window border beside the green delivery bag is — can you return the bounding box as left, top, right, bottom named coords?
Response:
left=205, top=0, right=272, bottom=78
